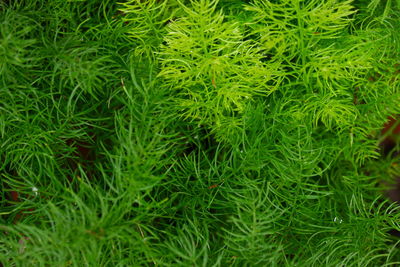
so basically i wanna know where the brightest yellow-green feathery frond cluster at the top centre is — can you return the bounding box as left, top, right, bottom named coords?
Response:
left=159, top=1, right=279, bottom=140
